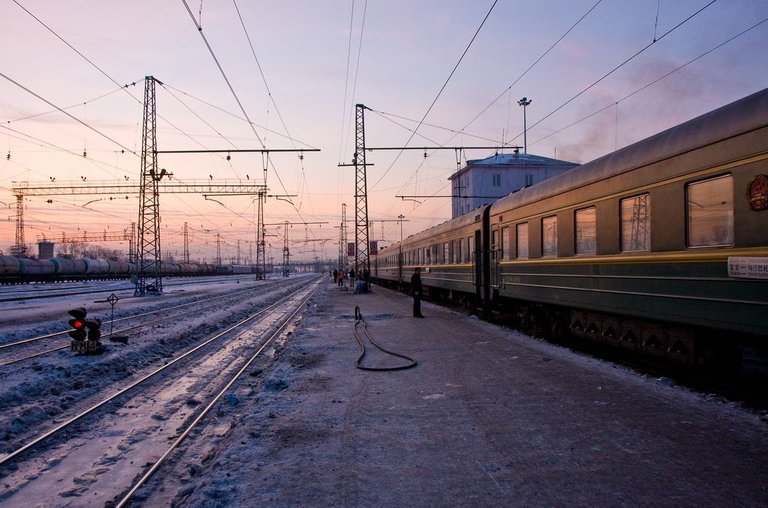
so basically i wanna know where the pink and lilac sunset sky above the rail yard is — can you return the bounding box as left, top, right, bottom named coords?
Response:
left=0, top=0, right=768, bottom=261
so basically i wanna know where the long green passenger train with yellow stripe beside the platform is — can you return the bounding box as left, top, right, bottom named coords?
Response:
left=371, top=89, right=768, bottom=371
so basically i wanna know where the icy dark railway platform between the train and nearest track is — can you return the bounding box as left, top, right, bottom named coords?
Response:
left=176, top=281, right=768, bottom=507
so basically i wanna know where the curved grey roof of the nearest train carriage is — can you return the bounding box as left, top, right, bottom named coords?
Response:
left=491, top=88, right=768, bottom=213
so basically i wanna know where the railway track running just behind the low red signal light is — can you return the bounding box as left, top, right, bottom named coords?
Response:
left=0, top=281, right=304, bottom=367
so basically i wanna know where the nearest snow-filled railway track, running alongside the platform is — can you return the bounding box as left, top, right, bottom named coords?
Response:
left=0, top=279, right=319, bottom=506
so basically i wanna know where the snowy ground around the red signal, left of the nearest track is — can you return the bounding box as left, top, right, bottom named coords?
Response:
left=0, top=277, right=312, bottom=453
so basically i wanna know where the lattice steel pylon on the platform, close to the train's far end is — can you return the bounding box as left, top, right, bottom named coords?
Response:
left=353, top=104, right=371, bottom=274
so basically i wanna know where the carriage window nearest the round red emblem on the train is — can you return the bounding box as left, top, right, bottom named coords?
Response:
left=686, top=175, right=733, bottom=247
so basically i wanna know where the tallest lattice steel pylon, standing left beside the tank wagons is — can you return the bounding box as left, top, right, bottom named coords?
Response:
left=134, top=76, right=165, bottom=296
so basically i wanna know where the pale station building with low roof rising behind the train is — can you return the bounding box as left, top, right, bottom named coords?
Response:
left=448, top=150, right=579, bottom=218
